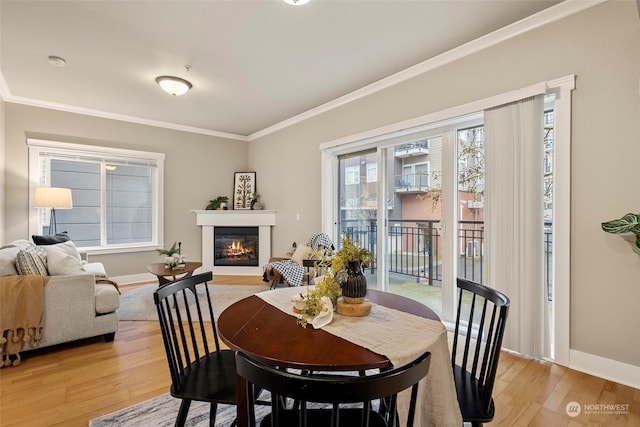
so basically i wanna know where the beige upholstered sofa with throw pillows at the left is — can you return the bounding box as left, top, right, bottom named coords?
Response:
left=0, top=240, right=120, bottom=358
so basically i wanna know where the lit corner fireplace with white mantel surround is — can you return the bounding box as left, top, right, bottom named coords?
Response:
left=192, top=209, right=277, bottom=276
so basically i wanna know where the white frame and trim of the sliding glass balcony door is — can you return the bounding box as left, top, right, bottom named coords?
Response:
left=320, top=75, right=575, bottom=366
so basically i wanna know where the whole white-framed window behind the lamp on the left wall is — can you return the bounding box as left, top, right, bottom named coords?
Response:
left=27, top=139, right=164, bottom=250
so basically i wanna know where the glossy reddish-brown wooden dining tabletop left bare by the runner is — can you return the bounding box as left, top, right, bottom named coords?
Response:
left=218, top=289, right=440, bottom=426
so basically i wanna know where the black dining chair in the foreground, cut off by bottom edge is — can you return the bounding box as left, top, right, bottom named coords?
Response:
left=236, top=352, right=431, bottom=427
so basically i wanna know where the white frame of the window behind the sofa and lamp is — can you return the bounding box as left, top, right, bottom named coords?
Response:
left=27, top=138, right=165, bottom=254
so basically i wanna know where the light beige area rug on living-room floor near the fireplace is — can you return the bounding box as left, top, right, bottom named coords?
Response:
left=118, top=283, right=269, bottom=320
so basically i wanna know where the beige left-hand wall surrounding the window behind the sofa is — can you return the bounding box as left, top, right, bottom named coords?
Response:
left=4, top=103, right=247, bottom=277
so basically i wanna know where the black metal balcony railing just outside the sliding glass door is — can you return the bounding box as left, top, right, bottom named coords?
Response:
left=342, top=219, right=553, bottom=301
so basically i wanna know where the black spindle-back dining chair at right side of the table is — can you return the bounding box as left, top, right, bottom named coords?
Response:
left=451, top=278, right=510, bottom=426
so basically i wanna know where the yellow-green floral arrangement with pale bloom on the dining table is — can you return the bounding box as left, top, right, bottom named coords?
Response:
left=298, top=238, right=374, bottom=328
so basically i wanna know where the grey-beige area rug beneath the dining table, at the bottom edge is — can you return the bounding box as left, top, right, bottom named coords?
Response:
left=89, top=393, right=264, bottom=427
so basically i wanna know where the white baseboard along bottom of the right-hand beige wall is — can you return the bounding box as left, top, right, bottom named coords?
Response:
left=569, top=350, right=640, bottom=389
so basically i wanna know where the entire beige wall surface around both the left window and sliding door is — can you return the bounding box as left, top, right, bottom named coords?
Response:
left=0, top=0, right=640, bottom=367
